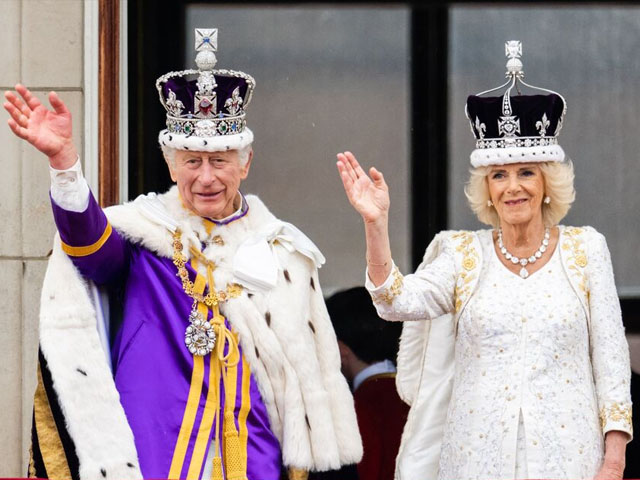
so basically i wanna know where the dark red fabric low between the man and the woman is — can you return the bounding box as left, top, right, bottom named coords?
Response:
left=353, top=374, right=409, bottom=480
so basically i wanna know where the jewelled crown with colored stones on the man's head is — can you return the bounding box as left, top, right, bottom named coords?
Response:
left=156, top=28, right=256, bottom=151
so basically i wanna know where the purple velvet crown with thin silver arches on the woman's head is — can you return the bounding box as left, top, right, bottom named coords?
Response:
left=465, top=40, right=567, bottom=167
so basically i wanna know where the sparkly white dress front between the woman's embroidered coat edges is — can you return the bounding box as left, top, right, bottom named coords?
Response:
left=439, top=244, right=603, bottom=480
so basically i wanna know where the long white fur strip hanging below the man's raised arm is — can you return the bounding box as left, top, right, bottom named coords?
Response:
left=40, top=238, right=142, bottom=480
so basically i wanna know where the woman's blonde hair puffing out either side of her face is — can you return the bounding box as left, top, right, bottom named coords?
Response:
left=464, top=159, right=576, bottom=228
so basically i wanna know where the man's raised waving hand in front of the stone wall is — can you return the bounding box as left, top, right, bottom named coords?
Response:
left=4, top=85, right=78, bottom=170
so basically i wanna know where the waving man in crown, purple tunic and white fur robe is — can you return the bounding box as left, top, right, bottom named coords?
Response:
left=5, top=30, right=362, bottom=480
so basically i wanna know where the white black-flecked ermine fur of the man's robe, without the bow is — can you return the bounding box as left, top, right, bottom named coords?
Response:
left=41, top=187, right=362, bottom=472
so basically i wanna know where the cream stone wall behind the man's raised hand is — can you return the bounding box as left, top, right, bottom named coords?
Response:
left=0, top=0, right=84, bottom=477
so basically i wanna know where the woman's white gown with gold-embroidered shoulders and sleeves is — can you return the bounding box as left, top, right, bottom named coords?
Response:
left=366, top=227, right=632, bottom=480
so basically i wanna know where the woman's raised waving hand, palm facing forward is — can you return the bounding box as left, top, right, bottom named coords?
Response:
left=337, top=152, right=390, bottom=223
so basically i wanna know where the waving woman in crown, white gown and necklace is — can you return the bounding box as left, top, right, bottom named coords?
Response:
left=337, top=42, right=632, bottom=480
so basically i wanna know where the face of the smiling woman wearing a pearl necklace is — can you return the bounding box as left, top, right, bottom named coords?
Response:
left=487, top=163, right=544, bottom=225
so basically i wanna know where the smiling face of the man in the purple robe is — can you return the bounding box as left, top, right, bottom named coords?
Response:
left=169, top=150, right=251, bottom=219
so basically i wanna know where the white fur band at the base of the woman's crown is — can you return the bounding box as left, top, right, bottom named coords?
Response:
left=471, top=145, right=565, bottom=167
